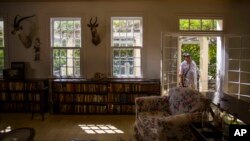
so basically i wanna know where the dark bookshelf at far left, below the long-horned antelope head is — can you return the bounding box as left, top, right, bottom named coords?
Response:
left=0, top=79, right=48, bottom=119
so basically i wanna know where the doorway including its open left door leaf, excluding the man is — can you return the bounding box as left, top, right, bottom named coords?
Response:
left=161, top=33, right=224, bottom=95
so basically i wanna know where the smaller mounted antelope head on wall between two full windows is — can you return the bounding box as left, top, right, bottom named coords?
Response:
left=88, top=17, right=101, bottom=46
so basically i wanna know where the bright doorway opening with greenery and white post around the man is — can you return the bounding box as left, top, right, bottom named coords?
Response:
left=178, top=35, right=222, bottom=92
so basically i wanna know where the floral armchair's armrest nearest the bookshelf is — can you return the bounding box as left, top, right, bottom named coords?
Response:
left=135, top=96, right=169, bottom=113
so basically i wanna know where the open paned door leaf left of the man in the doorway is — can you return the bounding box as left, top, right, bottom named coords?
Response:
left=161, top=33, right=178, bottom=95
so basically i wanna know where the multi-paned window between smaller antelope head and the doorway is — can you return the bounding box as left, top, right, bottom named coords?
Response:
left=111, top=17, right=143, bottom=77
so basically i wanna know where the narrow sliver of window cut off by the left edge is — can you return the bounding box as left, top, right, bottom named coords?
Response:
left=0, top=17, right=5, bottom=77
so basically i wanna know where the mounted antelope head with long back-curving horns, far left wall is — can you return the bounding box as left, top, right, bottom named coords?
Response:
left=11, top=15, right=35, bottom=48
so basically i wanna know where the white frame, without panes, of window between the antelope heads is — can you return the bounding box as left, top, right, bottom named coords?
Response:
left=50, top=16, right=83, bottom=78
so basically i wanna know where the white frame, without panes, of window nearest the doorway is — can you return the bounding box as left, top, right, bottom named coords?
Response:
left=110, top=16, right=144, bottom=78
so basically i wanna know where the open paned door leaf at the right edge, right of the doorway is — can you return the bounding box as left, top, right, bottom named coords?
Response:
left=225, top=35, right=250, bottom=102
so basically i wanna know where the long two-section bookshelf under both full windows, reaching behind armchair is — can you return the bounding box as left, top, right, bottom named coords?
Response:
left=52, top=79, right=160, bottom=114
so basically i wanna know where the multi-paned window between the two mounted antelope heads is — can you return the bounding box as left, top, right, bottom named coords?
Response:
left=50, top=18, right=82, bottom=77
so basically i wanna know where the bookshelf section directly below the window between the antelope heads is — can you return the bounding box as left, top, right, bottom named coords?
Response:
left=52, top=79, right=108, bottom=114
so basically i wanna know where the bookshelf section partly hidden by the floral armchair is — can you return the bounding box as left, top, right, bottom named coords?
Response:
left=108, top=79, right=160, bottom=114
